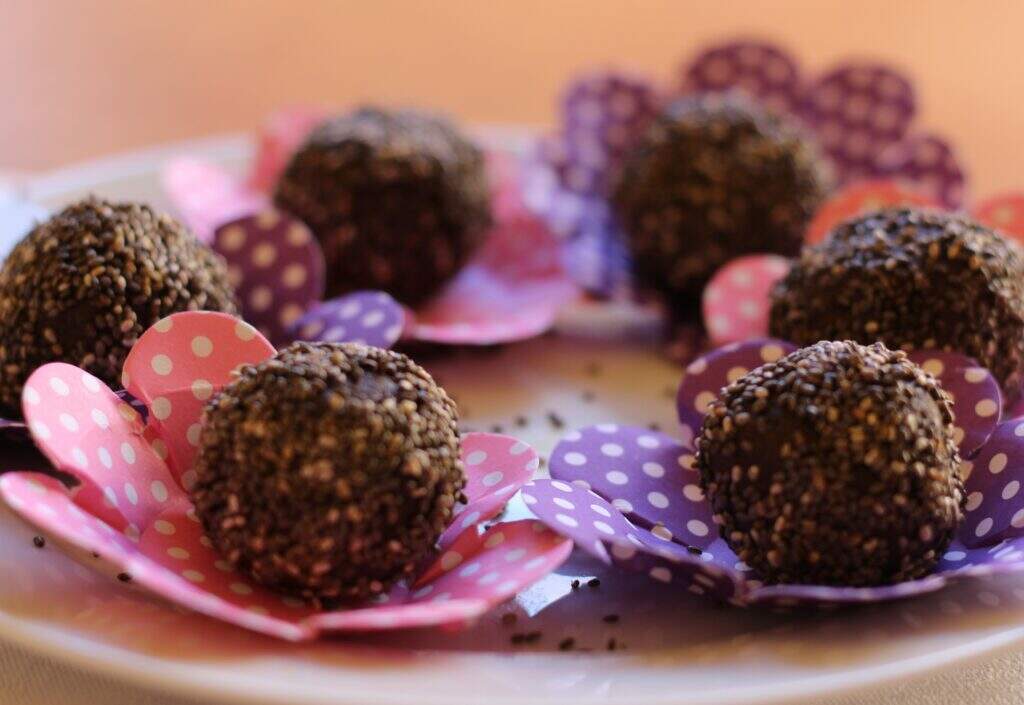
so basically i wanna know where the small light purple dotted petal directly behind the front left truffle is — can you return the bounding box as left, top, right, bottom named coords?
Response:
left=289, top=291, right=406, bottom=347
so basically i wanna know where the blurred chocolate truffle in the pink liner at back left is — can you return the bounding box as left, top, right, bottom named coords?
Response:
left=274, top=108, right=490, bottom=305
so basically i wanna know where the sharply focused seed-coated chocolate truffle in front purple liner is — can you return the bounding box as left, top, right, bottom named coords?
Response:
left=697, top=341, right=964, bottom=586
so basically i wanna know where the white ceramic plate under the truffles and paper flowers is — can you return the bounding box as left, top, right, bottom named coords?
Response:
left=0, top=132, right=1024, bottom=705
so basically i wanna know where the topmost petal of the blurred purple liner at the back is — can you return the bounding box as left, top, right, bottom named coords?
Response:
left=681, top=41, right=802, bottom=115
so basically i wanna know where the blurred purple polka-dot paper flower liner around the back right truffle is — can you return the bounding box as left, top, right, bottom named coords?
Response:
left=526, top=41, right=966, bottom=295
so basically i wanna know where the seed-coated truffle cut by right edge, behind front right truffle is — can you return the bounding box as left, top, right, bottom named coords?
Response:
left=770, top=208, right=1024, bottom=399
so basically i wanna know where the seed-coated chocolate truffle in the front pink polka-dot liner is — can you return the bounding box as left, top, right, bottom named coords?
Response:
left=191, top=342, right=465, bottom=605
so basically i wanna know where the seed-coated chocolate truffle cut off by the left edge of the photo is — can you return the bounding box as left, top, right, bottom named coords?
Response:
left=0, top=198, right=237, bottom=414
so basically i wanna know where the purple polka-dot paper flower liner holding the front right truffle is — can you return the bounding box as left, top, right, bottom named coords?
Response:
left=523, top=339, right=1024, bottom=607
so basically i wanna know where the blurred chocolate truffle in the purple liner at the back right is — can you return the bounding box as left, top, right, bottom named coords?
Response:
left=612, top=95, right=828, bottom=310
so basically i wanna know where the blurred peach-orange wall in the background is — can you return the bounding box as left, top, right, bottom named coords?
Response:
left=0, top=0, right=1024, bottom=194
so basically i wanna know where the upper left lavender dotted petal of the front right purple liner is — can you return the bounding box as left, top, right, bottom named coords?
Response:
left=549, top=424, right=717, bottom=548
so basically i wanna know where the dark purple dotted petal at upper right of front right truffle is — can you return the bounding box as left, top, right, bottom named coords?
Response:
left=907, top=350, right=1002, bottom=460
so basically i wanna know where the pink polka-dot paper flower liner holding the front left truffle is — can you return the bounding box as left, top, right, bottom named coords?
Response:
left=0, top=312, right=571, bottom=640
